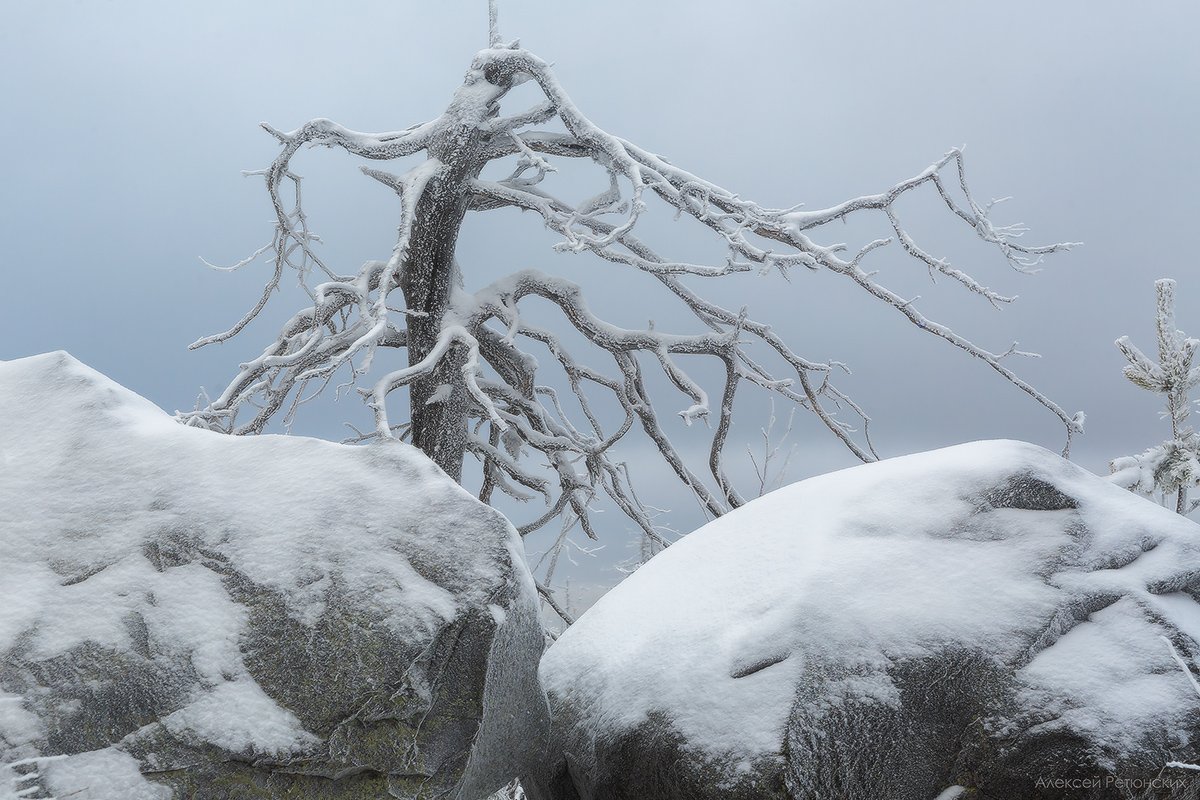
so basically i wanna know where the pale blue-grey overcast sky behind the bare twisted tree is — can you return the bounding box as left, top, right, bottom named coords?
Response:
left=0, top=0, right=1200, bottom=606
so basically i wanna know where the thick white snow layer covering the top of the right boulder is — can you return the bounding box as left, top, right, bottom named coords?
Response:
left=541, top=441, right=1200, bottom=766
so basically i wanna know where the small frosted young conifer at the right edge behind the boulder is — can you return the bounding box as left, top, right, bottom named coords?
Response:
left=1109, top=278, right=1200, bottom=515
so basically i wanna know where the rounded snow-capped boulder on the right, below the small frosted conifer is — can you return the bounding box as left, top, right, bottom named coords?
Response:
left=527, top=441, right=1200, bottom=800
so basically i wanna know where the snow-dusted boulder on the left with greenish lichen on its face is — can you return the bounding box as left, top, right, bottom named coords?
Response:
left=0, top=353, right=547, bottom=800
